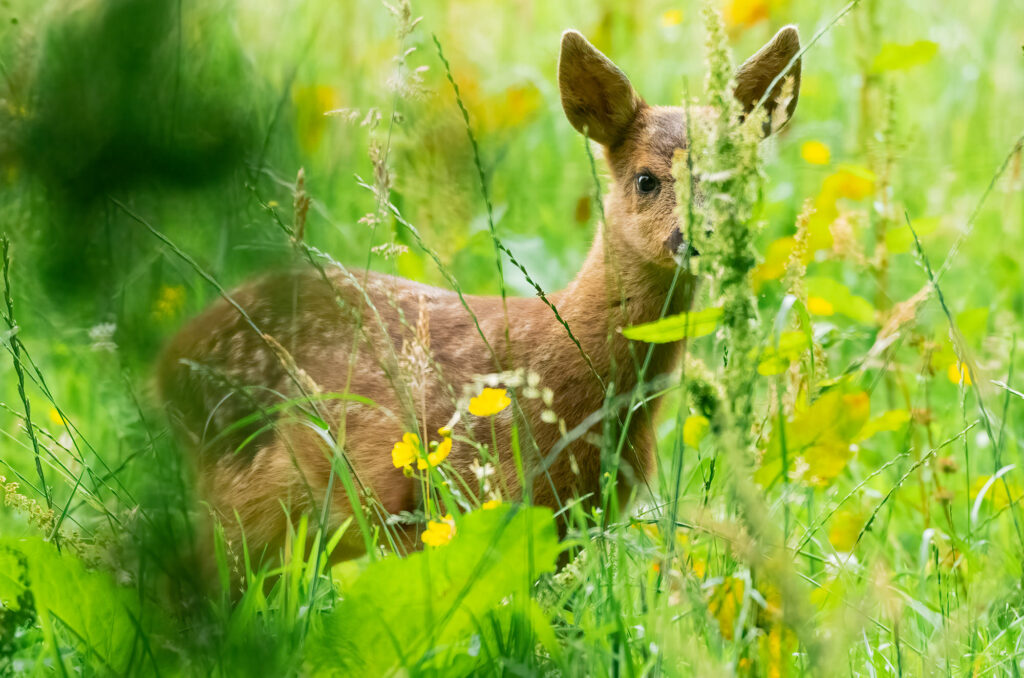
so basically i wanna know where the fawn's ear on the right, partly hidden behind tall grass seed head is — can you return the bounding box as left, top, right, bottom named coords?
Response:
left=733, top=26, right=801, bottom=133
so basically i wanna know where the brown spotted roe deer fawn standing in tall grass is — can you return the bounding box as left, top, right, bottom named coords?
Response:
left=158, top=27, right=800, bottom=558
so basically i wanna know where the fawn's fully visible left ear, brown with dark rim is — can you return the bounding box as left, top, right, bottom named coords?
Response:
left=558, top=31, right=643, bottom=145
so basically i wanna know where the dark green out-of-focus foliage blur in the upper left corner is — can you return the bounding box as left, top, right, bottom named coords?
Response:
left=0, top=0, right=260, bottom=301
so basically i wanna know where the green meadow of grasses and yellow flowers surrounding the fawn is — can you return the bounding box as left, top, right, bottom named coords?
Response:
left=0, top=0, right=1024, bottom=677
